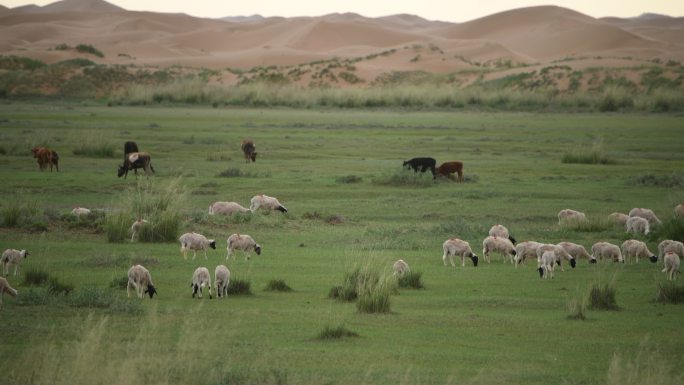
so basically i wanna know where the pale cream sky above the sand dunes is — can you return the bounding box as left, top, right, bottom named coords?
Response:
left=0, top=0, right=684, bottom=23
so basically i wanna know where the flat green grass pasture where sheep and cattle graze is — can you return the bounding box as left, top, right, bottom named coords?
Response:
left=0, top=102, right=684, bottom=384
